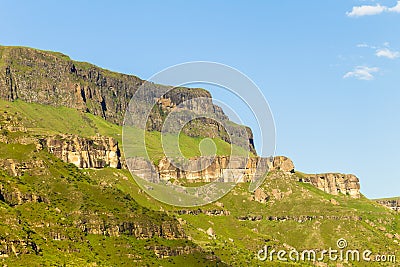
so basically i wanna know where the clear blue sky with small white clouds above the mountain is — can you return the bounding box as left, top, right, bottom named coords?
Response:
left=0, top=0, right=400, bottom=198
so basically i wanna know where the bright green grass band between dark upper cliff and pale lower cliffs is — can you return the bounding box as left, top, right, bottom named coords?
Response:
left=0, top=100, right=247, bottom=162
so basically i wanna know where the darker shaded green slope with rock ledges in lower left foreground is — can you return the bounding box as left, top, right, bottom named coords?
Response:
left=0, top=144, right=225, bottom=266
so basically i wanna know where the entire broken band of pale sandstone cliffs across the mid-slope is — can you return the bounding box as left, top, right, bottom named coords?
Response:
left=40, top=135, right=360, bottom=202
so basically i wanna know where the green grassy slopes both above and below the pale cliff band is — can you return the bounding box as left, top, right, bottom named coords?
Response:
left=0, top=101, right=400, bottom=266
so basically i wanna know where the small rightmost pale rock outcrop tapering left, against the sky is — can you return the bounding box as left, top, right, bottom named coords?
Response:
left=300, top=173, right=360, bottom=198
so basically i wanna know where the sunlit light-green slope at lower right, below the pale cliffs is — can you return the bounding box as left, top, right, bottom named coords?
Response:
left=89, top=169, right=400, bottom=266
